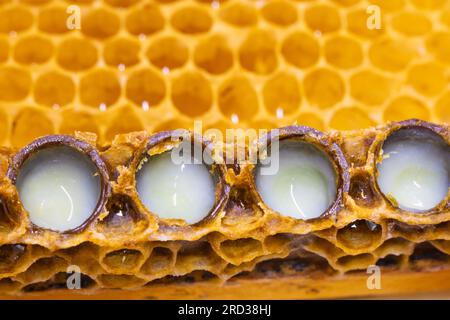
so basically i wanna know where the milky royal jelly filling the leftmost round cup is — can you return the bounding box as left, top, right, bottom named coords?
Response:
left=16, top=146, right=101, bottom=232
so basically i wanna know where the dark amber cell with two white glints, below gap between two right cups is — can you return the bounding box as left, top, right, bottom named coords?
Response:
left=336, top=220, right=382, bottom=250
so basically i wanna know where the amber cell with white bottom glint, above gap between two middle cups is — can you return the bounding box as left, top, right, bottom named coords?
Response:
left=218, top=76, right=258, bottom=122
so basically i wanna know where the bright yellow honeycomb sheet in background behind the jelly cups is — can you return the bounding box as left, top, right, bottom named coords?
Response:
left=0, top=0, right=442, bottom=148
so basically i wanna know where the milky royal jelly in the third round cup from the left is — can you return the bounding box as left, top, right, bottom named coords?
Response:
left=255, top=140, right=337, bottom=220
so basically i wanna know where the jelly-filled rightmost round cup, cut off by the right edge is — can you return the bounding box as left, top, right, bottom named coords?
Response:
left=377, top=127, right=450, bottom=212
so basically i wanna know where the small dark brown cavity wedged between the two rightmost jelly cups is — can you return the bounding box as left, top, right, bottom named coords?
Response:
left=348, top=173, right=381, bottom=208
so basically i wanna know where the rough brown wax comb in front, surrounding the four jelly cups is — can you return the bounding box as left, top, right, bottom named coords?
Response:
left=0, top=120, right=450, bottom=295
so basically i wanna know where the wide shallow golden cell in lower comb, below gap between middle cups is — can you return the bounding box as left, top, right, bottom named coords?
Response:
left=220, top=238, right=263, bottom=265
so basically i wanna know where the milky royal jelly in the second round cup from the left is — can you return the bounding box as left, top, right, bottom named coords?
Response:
left=136, top=151, right=215, bottom=224
